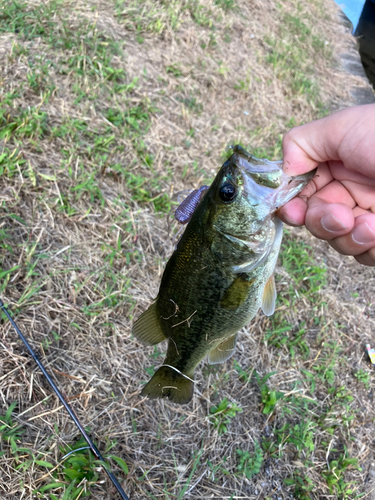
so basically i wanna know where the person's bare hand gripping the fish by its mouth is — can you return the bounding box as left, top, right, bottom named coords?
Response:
left=278, top=104, right=375, bottom=266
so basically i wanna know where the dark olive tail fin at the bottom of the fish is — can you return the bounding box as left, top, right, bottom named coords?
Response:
left=141, top=366, right=194, bottom=404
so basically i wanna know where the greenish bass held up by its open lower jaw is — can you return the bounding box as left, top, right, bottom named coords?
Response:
left=132, top=145, right=315, bottom=404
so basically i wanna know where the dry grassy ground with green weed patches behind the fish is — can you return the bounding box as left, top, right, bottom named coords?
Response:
left=0, top=0, right=374, bottom=499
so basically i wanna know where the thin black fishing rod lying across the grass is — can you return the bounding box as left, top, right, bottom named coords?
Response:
left=0, top=299, right=129, bottom=500
